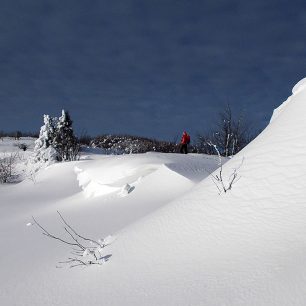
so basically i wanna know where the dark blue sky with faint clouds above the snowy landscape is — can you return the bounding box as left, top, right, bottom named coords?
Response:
left=0, top=0, right=306, bottom=140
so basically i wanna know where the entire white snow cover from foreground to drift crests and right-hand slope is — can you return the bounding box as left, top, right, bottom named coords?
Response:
left=0, top=79, right=306, bottom=306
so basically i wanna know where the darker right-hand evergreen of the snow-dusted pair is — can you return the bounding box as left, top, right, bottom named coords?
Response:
left=52, top=110, right=80, bottom=161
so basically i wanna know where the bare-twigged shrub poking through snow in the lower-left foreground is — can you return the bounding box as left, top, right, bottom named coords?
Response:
left=31, top=211, right=111, bottom=268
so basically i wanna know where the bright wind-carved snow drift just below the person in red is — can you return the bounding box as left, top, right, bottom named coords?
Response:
left=74, top=153, right=216, bottom=198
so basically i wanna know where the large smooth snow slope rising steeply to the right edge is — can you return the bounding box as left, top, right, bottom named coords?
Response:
left=98, top=81, right=306, bottom=306
